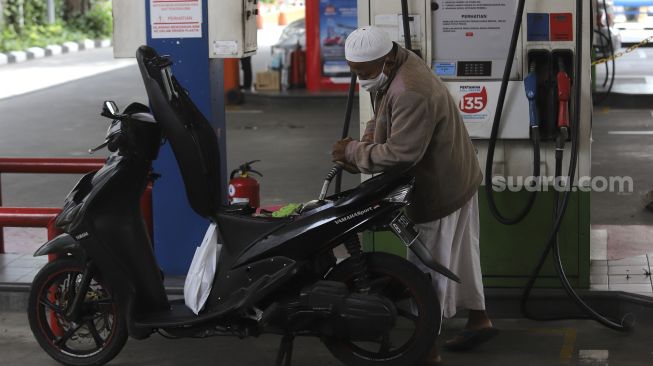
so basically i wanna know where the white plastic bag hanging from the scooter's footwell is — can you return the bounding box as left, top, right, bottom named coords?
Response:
left=184, top=223, right=222, bottom=314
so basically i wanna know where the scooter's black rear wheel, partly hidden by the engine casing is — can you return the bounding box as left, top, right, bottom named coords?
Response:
left=324, top=252, right=441, bottom=366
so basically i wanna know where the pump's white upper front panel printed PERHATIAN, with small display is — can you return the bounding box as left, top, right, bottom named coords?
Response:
left=432, top=0, right=519, bottom=78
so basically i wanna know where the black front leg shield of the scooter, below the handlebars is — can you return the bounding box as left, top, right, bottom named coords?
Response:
left=72, top=158, right=169, bottom=314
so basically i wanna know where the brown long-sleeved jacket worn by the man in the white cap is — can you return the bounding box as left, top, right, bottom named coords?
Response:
left=345, top=46, right=482, bottom=223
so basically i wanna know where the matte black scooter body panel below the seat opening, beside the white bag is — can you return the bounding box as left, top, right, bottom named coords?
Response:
left=217, top=210, right=293, bottom=252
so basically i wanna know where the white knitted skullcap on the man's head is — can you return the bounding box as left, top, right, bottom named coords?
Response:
left=345, top=25, right=392, bottom=62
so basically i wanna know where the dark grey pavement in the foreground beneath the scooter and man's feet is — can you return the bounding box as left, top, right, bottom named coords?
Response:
left=0, top=312, right=653, bottom=366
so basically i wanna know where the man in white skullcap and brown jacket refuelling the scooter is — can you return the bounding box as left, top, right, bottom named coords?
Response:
left=332, top=26, right=497, bottom=364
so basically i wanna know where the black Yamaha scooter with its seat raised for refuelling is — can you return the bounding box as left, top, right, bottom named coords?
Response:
left=28, top=46, right=457, bottom=366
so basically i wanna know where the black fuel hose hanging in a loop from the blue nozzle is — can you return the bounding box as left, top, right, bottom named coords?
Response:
left=485, top=0, right=540, bottom=225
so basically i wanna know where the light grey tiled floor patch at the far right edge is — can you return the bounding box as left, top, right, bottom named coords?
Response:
left=590, top=254, right=653, bottom=296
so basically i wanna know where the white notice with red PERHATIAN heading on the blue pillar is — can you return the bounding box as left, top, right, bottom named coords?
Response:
left=150, top=0, right=202, bottom=38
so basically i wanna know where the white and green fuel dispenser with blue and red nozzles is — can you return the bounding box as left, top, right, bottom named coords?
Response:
left=358, top=0, right=591, bottom=294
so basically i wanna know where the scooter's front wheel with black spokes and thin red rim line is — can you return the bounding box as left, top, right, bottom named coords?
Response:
left=27, top=258, right=127, bottom=366
